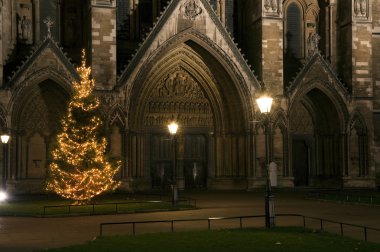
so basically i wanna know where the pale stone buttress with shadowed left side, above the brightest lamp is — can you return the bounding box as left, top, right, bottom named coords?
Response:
left=241, top=0, right=283, bottom=96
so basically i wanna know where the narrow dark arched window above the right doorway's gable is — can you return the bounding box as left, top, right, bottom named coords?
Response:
left=285, top=3, right=302, bottom=59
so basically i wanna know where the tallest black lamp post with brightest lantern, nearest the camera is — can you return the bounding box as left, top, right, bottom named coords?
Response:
left=256, top=96, right=276, bottom=228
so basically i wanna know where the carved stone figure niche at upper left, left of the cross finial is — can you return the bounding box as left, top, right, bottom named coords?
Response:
left=16, top=1, right=33, bottom=45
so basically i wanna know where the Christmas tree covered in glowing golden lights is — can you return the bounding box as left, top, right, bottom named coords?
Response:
left=46, top=50, right=121, bottom=204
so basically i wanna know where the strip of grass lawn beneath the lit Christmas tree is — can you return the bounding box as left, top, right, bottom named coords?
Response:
left=0, top=195, right=191, bottom=216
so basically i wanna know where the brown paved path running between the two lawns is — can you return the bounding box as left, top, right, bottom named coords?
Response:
left=0, top=192, right=380, bottom=252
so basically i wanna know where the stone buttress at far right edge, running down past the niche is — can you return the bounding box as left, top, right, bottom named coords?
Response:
left=344, top=0, right=376, bottom=187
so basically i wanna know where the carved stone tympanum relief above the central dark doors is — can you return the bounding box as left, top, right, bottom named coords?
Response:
left=144, top=68, right=213, bottom=127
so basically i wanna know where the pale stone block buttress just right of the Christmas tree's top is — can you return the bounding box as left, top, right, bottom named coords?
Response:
left=91, top=0, right=116, bottom=89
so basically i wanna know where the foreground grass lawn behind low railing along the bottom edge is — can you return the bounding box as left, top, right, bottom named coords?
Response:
left=39, top=228, right=380, bottom=252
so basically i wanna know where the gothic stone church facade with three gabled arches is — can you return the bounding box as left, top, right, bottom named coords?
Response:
left=0, top=0, right=380, bottom=193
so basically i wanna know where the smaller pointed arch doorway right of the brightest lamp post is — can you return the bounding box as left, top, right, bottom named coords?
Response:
left=290, top=88, right=344, bottom=188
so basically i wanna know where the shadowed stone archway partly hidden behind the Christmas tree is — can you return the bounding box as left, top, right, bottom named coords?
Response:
left=11, top=79, right=69, bottom=192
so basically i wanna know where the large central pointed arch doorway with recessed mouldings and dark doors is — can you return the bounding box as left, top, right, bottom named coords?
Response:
left=128, top=34, right=251, bottom=189
